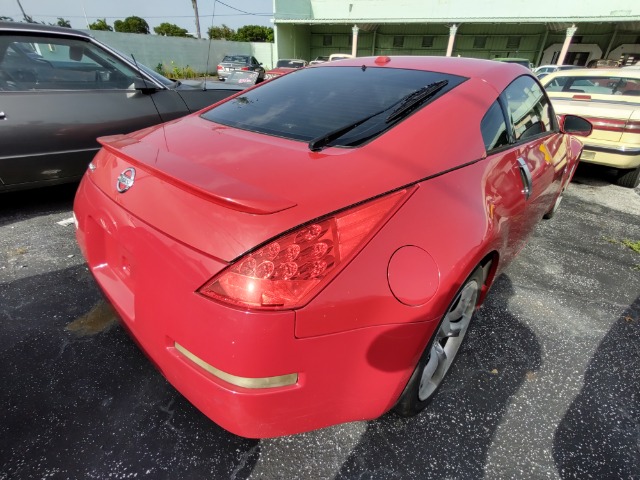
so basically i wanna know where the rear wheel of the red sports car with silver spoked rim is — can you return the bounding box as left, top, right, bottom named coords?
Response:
left=394, top=267, right=483, bottom=417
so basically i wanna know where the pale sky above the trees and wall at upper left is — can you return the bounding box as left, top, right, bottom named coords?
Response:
left=5, top=0, right=273, bottom=33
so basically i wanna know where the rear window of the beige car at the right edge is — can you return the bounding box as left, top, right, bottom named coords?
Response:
left=545, top=75, right=640, bottom=96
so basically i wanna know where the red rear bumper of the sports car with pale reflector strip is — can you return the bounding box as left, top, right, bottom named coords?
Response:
left=74, top=178, right=434, bottom=438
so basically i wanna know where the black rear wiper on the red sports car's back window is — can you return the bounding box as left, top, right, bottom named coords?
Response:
left=309, top=80, right=449, bottom=152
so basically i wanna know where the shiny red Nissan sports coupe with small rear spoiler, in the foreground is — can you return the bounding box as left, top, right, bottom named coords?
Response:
left=74, top=57, right=591, bottom=438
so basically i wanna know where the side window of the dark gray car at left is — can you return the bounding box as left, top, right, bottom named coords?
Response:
left=0, top=35, right=139, bottom=91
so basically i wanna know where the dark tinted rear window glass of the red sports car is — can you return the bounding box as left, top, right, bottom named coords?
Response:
left=202, top=67, right=466, bottom=146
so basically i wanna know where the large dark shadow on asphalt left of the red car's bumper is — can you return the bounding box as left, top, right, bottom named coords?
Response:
left=0, top=265, right=257, bottom=479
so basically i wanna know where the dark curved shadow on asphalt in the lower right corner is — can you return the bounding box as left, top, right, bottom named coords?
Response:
left=553, top=297, right=640, bottom=479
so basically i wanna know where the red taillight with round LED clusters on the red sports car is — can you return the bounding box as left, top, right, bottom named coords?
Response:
left=198, top=190, right=407, bottom=309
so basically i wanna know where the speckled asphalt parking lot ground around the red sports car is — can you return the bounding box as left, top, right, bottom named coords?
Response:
left=0, top=165, right=640, bottom=480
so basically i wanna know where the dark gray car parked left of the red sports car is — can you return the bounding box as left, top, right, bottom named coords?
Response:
left=0, top=22, right=246, bottom=192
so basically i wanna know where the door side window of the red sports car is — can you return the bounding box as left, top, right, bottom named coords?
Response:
left=502, top=75, right=555, bottom=142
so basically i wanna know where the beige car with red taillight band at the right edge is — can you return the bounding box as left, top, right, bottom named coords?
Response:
left=540, top=68, right=640, bottom=188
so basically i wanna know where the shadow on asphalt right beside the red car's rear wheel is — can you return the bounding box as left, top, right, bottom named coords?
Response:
left=318, top=275, right=541, bottom=479
